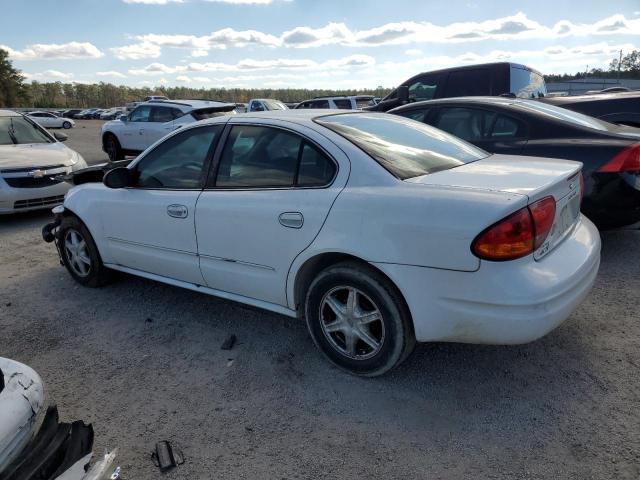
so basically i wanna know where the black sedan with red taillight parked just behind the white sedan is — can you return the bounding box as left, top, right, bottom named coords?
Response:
left=389, top=97, right=640, bottom=228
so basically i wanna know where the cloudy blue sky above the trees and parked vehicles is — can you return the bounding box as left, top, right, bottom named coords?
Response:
left=0, top=0, right=640, bottom=89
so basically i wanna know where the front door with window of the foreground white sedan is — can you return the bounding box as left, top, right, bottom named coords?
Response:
left=102, top=125, right=222, bottom=285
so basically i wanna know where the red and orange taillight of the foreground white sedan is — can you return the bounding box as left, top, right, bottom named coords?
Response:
left=471, top=197, right=556, bottom=261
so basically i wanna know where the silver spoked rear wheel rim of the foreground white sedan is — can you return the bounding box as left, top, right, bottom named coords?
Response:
left=320, top=286, right=385, bottom=360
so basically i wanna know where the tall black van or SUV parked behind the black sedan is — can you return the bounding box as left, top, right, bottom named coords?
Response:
left=365, top=62, right=547, bottom=112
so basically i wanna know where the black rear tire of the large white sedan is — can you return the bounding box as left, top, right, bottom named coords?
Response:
left=305, top=262, right=416, bottom=377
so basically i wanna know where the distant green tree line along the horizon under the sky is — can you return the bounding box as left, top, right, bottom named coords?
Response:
left=0, top=49, right=640, bottom=108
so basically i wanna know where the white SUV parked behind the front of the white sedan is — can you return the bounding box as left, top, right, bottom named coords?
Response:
left=102, top=100, right=236, bottom=161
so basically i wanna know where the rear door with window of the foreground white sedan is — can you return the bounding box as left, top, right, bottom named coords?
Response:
left=196, top=119, right=349, bottom=305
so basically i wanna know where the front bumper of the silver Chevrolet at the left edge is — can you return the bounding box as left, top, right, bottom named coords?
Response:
left=0, top=178, right=71, bottom=215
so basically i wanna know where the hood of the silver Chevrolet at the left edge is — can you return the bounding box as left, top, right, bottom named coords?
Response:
left=0, top=142, right=74, bottom=169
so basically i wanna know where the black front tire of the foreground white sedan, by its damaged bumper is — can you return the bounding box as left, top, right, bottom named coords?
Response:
left=56, top=215, right=112, bottom=288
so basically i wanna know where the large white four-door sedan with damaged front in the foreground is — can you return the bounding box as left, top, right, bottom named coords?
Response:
left=44, top=110, right=600, bottom=376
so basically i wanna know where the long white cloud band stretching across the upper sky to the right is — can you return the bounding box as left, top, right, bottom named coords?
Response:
left=123, top=13, right=640, bottom=58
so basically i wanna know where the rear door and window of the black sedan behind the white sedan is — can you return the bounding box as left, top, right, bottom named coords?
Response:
left=426, top=106, right=527, bottom=155
